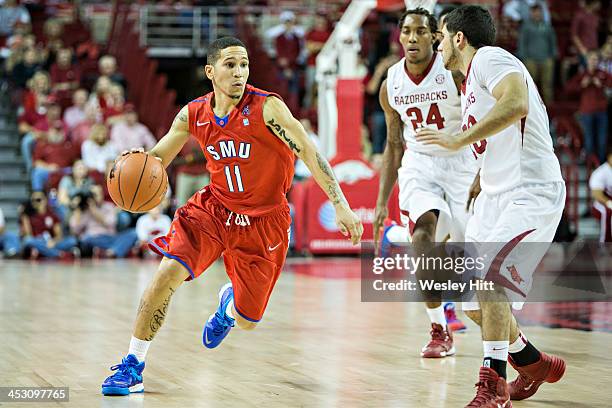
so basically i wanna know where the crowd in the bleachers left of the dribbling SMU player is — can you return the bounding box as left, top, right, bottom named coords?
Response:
left=0, top=1, right=177, bottom=259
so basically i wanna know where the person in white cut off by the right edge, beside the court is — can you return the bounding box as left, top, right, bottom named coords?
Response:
left=589, top=150, right=612, bottom=242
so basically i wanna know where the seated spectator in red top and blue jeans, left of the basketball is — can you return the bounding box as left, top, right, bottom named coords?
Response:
left=32, top=115, right=80, bottom=191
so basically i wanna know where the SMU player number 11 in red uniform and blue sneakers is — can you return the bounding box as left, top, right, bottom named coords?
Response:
left=102, top=37, right=363, bottom=395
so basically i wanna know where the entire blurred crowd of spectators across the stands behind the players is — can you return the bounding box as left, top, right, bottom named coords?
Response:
left=0, top=0, right=612, bottom=258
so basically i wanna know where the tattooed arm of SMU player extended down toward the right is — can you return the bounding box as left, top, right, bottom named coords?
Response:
left=264, top=97, right=363, bottom=244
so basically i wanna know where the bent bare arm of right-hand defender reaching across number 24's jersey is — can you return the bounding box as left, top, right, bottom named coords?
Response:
left=416, top=72, right=529, bottom=150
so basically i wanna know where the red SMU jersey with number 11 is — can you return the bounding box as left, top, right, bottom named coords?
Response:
left=188, top=85, right=295, bottom=216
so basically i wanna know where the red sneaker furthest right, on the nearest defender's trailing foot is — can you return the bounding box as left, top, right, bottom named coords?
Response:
left=508, top=353, right=565, bottom=401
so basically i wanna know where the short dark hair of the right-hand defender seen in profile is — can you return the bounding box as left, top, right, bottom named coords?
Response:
left=444, top=6, right=495, bottom=48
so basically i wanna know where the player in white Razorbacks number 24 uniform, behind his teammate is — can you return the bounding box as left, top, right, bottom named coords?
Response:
left=374, top=8, right=478, bottom=358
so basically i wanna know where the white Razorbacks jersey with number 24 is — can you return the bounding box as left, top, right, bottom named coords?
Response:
left=387, top=53, right=461, bottom=156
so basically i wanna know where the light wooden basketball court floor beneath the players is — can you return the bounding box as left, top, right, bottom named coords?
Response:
left=0, top=260, right=612, bottom=408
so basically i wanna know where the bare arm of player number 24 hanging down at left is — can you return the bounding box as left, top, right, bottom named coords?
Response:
left=373, top=79, right=404, bottom=248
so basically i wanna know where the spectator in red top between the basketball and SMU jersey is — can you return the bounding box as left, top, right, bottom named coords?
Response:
left=175, top=137, right=210, bottom=206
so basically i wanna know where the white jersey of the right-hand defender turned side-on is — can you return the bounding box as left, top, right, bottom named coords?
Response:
left=461, top=47, right=563, bottom=194
